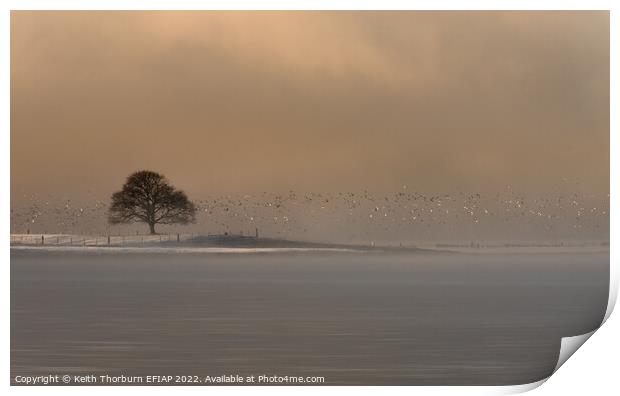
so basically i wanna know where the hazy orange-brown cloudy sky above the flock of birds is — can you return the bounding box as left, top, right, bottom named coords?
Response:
left=11, top=11, right=609, bottom=206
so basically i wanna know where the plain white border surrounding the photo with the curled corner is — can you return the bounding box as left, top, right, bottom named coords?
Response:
left=0, top=0, right=620, bottom=395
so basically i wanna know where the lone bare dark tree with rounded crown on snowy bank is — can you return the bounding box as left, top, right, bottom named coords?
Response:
left=108, top=170, right=196, bottom=234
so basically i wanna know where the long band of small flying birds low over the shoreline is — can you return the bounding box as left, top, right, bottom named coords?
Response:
left=11, top=187, right=609, bottom=240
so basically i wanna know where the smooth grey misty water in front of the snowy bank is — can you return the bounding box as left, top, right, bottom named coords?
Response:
left=11, top=247, right=609, bottom=385
